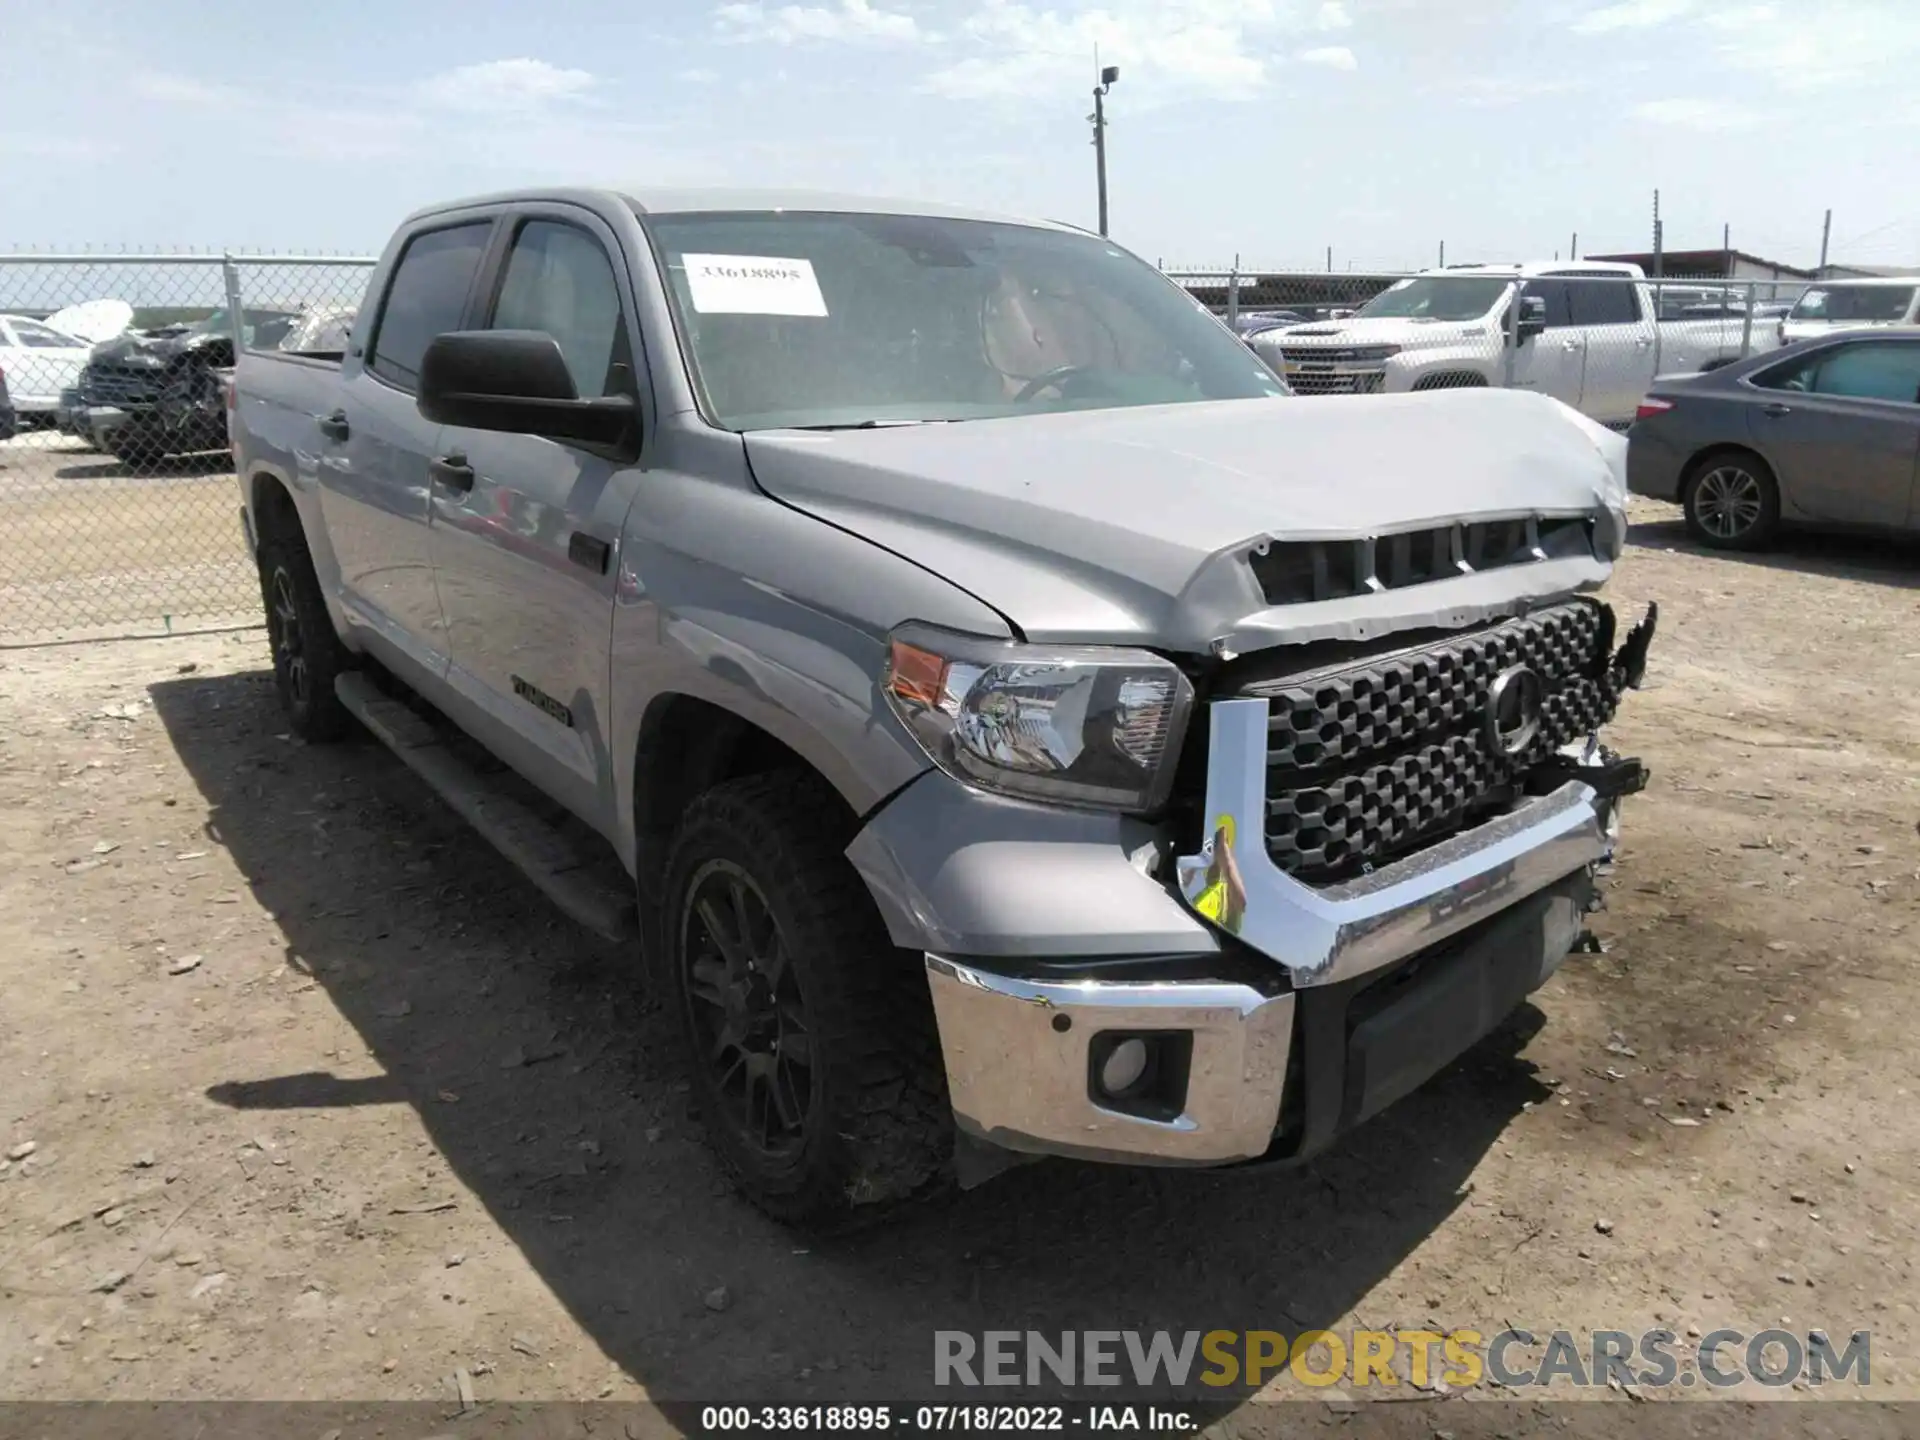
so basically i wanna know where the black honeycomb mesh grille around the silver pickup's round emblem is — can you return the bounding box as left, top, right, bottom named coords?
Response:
left=1238, top=601, right=1619, bottom=881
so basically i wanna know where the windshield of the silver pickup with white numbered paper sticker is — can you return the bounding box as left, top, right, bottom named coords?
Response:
left=643, top=211, right=1286, bottom=430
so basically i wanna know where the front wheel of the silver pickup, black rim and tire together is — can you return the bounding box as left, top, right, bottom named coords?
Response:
left=657, top=770, right=952, bottom=1229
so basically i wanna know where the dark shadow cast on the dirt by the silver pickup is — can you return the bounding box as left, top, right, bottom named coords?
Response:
left=152, top=672, right=1549, bottom=1404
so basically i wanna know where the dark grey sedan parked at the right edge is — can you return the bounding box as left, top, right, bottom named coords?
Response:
left=1626, top=328, right=1920, bottom=549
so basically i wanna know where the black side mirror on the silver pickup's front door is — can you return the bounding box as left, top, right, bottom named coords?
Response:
left=417, top=330, right=639, bottom=445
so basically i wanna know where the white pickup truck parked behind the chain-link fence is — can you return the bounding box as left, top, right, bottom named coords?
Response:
left=1248, top=261, right=1780, bottom=424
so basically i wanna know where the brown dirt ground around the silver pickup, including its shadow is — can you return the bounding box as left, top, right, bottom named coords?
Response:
left=0, top=507, right=1920, bottom=1428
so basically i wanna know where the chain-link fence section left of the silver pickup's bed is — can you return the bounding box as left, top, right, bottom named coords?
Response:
left=0, top=253, right=372, bottom=645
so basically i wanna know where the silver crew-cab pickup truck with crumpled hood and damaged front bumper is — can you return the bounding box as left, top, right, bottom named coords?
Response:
left=232, top=190, right=1653, bottom=1225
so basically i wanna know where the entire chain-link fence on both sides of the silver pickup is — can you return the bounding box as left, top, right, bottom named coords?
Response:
left=0, top=253, right=1793, bottom=645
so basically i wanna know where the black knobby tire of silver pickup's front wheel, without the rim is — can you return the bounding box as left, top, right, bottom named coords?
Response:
left=651, top=770, right=952, bottom=1231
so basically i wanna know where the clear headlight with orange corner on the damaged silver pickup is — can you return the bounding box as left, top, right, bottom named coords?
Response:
left=881, top=626, right=1194, bottom=812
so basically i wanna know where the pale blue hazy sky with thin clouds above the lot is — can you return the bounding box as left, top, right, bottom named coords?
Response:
left=0, top=0, right=1920, bottom=269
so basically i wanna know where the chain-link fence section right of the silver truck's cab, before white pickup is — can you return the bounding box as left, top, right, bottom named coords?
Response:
left=1167, top=261, right=1793, bottom=428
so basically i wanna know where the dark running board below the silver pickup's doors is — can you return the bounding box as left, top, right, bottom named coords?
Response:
left=334, top=670, right=639, bottom=943
